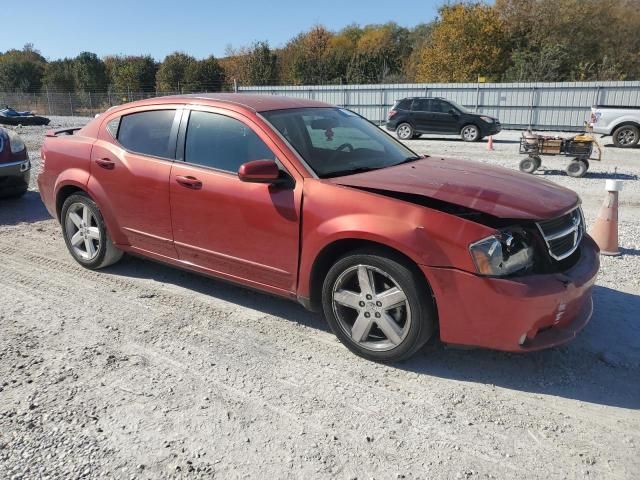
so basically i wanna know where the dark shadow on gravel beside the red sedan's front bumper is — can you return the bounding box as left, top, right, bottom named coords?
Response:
left=399, top=286, right=640, bottom=409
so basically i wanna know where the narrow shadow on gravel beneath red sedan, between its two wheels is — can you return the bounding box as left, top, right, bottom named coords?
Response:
left=105, top=255, right=330, bottom=332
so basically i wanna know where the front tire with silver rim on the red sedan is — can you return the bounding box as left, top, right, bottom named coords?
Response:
left=322, top=251, right=436, bottom=362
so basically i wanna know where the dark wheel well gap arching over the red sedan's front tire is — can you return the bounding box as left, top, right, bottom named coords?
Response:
left=307, top=238, right=438, bottom=324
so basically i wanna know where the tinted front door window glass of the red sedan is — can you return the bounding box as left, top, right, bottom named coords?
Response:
left=184, top=111, right=276, bottom=173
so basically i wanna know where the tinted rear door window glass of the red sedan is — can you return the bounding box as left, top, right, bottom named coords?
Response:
left=116, top=110, right=176, bottom=158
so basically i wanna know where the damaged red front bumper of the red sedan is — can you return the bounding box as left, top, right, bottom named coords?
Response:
left=421, top=236, right=600, bottom=352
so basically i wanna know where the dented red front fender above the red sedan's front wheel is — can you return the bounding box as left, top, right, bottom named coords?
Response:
left=298, top=180, right=494, bottom=297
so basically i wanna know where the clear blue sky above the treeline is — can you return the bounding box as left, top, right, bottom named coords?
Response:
left=0, top=0, right=444, bottom=60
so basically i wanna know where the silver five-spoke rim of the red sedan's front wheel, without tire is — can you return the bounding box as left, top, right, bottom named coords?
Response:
left=332, top=265, right=411, bottom=351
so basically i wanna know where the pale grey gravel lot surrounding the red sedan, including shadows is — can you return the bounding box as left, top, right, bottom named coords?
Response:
left=0, top=118, right=640, bottom=479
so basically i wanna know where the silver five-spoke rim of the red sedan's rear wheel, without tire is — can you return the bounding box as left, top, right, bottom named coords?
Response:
left=65, top=202, right=102, bottom=261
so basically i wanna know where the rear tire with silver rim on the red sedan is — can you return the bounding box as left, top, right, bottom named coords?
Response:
left=60, top=192, right=123, bottom=270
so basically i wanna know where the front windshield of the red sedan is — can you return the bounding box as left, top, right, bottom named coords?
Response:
left=262, top=107, right=419, bottom=178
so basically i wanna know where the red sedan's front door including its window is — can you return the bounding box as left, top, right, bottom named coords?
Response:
left=169, top=109, right=302, bottom=292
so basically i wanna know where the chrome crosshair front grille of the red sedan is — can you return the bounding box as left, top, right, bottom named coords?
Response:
left=537, top=208, right=584, bottom=260
